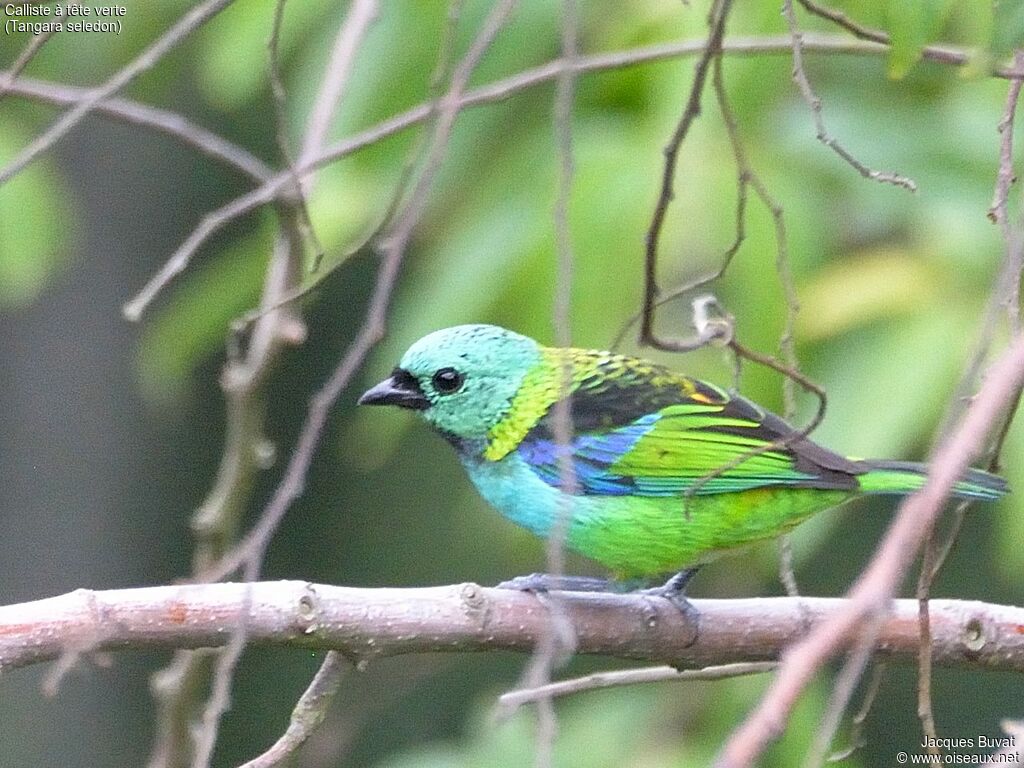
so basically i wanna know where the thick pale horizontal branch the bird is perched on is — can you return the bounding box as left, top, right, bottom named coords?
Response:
left=0, top=582, right=1024, bottom=672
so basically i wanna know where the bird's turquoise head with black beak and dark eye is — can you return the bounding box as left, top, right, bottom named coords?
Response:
left=359, top=325, right=541, bottom=445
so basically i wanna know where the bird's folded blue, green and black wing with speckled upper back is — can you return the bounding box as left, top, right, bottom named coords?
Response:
left=517, top=350, right=865, bottom=496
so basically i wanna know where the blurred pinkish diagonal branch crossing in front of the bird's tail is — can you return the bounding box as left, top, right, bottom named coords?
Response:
left=718, top=340, right=1024, bottom=768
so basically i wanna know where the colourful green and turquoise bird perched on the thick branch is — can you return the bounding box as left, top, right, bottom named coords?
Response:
left=358, top=325, right=1008, bottom=606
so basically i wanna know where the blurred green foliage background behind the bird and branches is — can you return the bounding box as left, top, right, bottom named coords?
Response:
left=0, top=0, right=1024, bottom=768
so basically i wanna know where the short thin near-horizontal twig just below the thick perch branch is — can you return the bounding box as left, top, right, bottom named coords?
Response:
left=498, top=662, right=778, bottom=719
